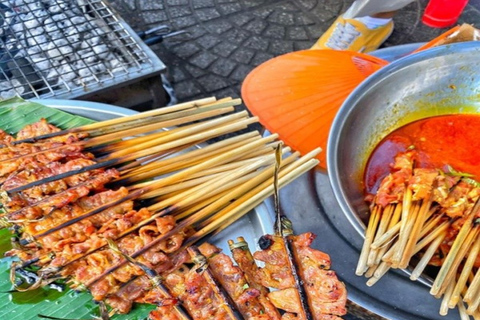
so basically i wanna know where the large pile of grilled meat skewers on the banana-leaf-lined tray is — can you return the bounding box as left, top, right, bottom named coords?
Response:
left=0, top=98, right=346, bottom=320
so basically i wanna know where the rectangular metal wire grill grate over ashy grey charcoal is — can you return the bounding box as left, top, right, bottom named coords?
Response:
left=0, top=0, right=165, bottom=98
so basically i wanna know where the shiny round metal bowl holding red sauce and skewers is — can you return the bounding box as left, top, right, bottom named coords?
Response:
left=327, top=42, right=480, bottom=237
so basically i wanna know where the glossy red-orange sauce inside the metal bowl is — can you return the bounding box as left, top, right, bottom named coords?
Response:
left=364, top=114, right=480, bottom=193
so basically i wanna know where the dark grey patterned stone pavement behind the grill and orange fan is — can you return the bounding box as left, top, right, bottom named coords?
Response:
left=111, top=0, right=480, bottom=101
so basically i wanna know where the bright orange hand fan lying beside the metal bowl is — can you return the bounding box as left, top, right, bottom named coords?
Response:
left=242, top=50, right=388, bottom=169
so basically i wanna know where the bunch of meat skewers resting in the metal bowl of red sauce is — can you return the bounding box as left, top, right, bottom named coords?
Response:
left=356, top=151, right=480, bottom=319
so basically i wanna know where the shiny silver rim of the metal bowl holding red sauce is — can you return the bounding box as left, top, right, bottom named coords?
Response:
left=327, top=41, right=480, bottom=237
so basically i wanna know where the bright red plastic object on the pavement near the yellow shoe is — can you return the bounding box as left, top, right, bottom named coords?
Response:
left=422, top=0, right=468, bottom=28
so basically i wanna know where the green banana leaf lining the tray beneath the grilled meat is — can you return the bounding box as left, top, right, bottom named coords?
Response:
left=0, top=97, right=154, bottom=320
